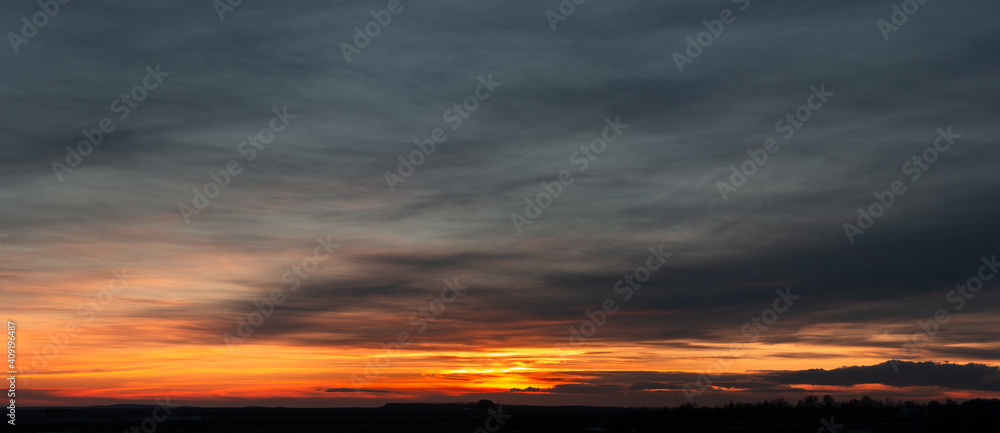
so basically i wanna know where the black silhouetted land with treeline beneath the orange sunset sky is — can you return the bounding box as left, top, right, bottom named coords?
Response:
left=4, top=399, right=1000, bottom=433
